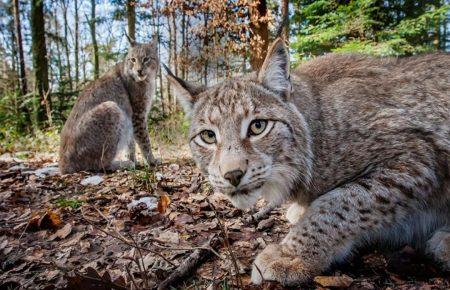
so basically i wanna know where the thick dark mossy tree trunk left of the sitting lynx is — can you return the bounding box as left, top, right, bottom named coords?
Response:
left=30, top=0, right=52, bottom=122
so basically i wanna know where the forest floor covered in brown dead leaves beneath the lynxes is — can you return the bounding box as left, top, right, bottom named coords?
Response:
left=0, top=147, right=450, bottom=290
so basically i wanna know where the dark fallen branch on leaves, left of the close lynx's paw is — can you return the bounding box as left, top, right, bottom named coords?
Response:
left=158, top=234, right=221, bottom=290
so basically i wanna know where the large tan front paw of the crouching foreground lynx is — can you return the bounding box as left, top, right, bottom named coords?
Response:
left=252, top=244, right=312, bottom=286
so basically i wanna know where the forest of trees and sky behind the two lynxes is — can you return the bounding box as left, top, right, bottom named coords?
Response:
left=0, top=0, right=450, bottom=154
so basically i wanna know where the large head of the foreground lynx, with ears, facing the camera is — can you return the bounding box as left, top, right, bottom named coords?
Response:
left=166, top=39, right=311, bottom=209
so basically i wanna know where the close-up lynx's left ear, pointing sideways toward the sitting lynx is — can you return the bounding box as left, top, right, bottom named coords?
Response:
left=163, top=64, right=206, bottom=114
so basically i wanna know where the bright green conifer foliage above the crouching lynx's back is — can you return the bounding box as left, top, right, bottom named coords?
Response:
left=291, top=0, right=450, bottom=59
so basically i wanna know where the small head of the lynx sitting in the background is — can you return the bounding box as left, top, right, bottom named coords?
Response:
left=124, top=36, right=159, bottom=82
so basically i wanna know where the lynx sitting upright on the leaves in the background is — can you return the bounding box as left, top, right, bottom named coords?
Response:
left=59, top=41, right=159, bottom=173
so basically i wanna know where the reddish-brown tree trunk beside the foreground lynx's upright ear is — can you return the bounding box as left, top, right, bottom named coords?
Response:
left=250, top=0, right=269, bottom=70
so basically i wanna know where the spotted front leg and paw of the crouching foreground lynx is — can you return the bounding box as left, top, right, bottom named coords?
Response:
left=252, top=156, right=436, bottom=285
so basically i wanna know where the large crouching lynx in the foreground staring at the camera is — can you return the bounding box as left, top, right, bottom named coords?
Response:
left=168, top=39, right=450, bottom=285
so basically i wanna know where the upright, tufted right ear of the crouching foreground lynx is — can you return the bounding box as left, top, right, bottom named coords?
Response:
left=258, top=38, right=291, bottom=98
